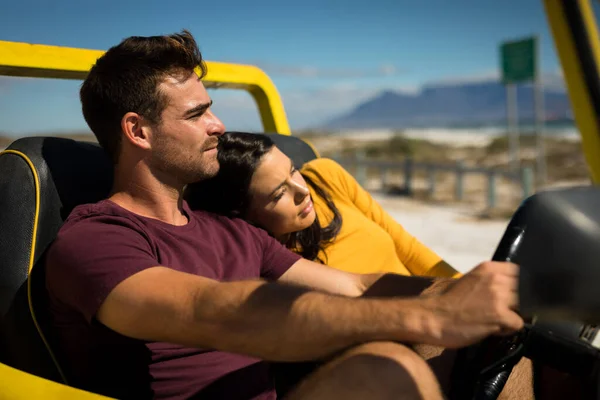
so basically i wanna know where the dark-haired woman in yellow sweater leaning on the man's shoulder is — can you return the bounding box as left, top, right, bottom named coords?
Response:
left=186, top=132, right=459, bottom=277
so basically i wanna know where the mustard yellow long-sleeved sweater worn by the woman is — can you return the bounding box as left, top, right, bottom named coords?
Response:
left=301, top=158, right=460, bottom=277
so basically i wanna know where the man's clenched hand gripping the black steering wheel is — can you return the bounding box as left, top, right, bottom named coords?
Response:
left=423, top=262, right=523, bottom=348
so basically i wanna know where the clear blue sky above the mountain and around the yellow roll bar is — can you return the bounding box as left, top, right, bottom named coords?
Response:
left=0, top=0, right=584, bottom=135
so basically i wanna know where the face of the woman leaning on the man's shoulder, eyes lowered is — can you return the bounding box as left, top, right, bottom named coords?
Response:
left=247, top=146, right=315, bottom=237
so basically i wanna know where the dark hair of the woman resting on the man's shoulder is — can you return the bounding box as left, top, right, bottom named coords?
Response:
left=184, top=132, right=342, bottom=263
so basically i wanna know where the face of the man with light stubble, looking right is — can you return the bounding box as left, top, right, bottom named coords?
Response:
left=150, top=73, right=225, bottom=185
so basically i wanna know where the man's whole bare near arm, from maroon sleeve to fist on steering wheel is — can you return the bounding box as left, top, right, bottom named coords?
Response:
left=96, top=264, right=522, bottom=361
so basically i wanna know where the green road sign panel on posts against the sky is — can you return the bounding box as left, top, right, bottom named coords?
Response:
left=500, top=37, right=537, bottom=84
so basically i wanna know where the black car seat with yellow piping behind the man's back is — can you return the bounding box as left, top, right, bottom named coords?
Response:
left=0, top=137, right=112, bottom=381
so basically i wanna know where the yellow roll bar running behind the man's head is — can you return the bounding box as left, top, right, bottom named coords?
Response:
left=0, top=40, right=291, bottom=135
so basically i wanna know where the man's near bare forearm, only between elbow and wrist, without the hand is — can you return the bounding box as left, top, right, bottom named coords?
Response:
left=194, top=281, right=431, bottom=361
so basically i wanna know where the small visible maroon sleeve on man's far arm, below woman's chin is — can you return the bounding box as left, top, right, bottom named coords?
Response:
left=249, top=226, right=302, bottom=281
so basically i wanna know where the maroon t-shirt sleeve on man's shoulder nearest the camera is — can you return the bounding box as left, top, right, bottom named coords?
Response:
left=46, top=216, right=158, bottom=322
